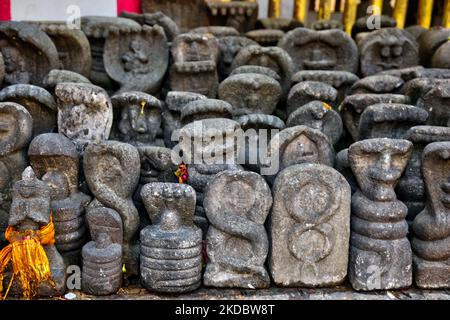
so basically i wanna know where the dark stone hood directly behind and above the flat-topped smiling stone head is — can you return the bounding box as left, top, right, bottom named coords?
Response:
left=358, top=103, right=428, bottom=140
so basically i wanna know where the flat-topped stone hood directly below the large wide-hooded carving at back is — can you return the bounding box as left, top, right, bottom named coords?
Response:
left=292, top=70, right=359, bottom=103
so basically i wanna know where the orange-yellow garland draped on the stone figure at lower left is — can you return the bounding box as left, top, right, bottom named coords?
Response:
left=0, top=216, right=55, bottom=300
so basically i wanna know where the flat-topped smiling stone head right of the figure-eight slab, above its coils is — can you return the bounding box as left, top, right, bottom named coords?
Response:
left=348, top=139, right=412, bottom=201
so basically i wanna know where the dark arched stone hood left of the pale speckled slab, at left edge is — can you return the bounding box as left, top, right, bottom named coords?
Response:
left=0, top=84, right=57, bottom=137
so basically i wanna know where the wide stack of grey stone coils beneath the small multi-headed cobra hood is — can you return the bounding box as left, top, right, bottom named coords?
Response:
left=141, top=225, right=202, bottom=292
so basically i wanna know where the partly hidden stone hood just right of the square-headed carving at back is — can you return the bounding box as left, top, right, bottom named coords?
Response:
left=218, top=36, right=258, bottom=80
